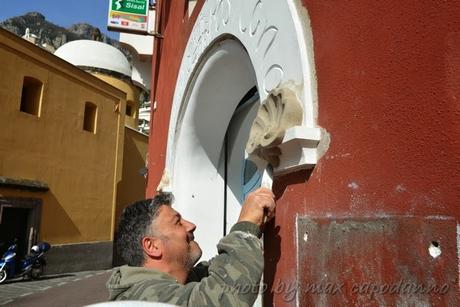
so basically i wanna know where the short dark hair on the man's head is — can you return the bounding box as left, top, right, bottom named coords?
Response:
left=116, top=193, right=174, bottom=266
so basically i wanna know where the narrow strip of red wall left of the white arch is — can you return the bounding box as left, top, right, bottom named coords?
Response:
left=146, top=0, right=204, bottom=197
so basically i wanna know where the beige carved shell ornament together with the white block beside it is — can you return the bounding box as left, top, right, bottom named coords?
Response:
left=246, top=85, right=329, bottom=175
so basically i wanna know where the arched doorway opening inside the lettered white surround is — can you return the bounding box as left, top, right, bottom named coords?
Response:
left=172, top=37, right=259, bottom=259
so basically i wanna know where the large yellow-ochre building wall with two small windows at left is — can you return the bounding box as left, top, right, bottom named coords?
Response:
left=0, top=31, right=126, bottom=244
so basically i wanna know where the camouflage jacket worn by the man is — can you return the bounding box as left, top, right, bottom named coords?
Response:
left=107, top=222, right=263, bottom=307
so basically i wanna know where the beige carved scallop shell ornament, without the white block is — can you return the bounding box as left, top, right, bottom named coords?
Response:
left=246, top=88, right=303, bottom=167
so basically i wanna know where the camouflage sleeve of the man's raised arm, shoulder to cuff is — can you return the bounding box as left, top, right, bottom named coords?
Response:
left=124, top=222, right=263, bottom=307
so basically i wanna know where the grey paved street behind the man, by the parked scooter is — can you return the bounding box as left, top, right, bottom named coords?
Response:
left=0, top=270, right=111, bottom=307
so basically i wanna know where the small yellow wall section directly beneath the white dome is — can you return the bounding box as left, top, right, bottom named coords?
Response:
left=93, top=73, right=140, bottom=130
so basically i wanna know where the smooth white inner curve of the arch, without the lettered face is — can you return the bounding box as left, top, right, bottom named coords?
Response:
left=172, top=40, right=256, bottom=257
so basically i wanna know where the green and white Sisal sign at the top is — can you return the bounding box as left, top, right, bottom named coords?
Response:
left=107, top=0, right=149, bottom=33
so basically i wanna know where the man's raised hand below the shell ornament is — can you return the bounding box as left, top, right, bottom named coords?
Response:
left=238, top=188, right=275, bottom=227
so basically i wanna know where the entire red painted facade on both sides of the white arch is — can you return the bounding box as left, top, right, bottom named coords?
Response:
left=147, top=0, right=460, bottom=306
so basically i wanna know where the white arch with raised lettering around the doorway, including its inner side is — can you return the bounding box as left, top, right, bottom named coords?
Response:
left=166, top=0, right=321, bottom=256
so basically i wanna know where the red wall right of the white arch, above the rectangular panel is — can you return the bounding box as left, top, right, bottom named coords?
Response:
left=266, top=0, right=460, bottom=305
